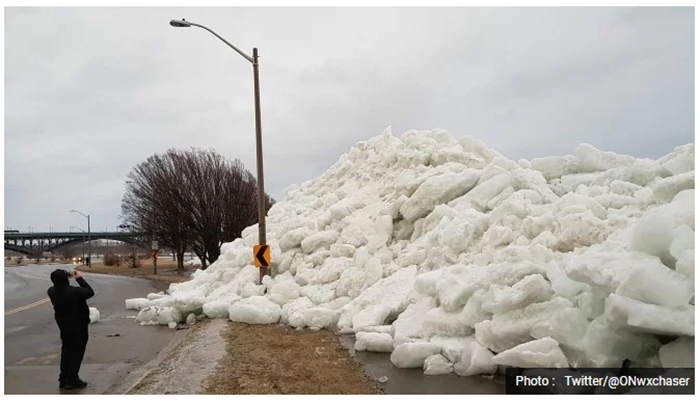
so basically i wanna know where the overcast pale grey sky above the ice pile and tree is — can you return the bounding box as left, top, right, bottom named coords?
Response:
left=4, top=7, right=695, bottom=231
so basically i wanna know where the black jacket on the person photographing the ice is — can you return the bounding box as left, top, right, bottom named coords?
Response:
left=46, top=277, right=95, bottom=331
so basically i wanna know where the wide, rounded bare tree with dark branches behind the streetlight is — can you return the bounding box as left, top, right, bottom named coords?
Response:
left=122, top=149, right=274, bottom=269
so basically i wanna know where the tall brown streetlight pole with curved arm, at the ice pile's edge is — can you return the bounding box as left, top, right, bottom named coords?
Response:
left=170, top=18, right=267, bottom=283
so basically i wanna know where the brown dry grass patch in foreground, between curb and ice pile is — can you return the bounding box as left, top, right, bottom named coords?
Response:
left=203, top=322, right=382, bottom=395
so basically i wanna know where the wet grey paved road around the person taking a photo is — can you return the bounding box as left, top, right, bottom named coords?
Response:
left=5, top=265, right=176, bottom=394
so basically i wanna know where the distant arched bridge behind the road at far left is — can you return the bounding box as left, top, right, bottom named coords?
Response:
left=5, top=232, right=150, bottom=257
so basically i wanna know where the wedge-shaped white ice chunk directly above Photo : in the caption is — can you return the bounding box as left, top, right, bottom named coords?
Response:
left=492, top=337, right=569, bottom=368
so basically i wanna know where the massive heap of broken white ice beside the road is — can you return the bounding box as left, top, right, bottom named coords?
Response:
left=127, top=130, right=695, bottom=375
